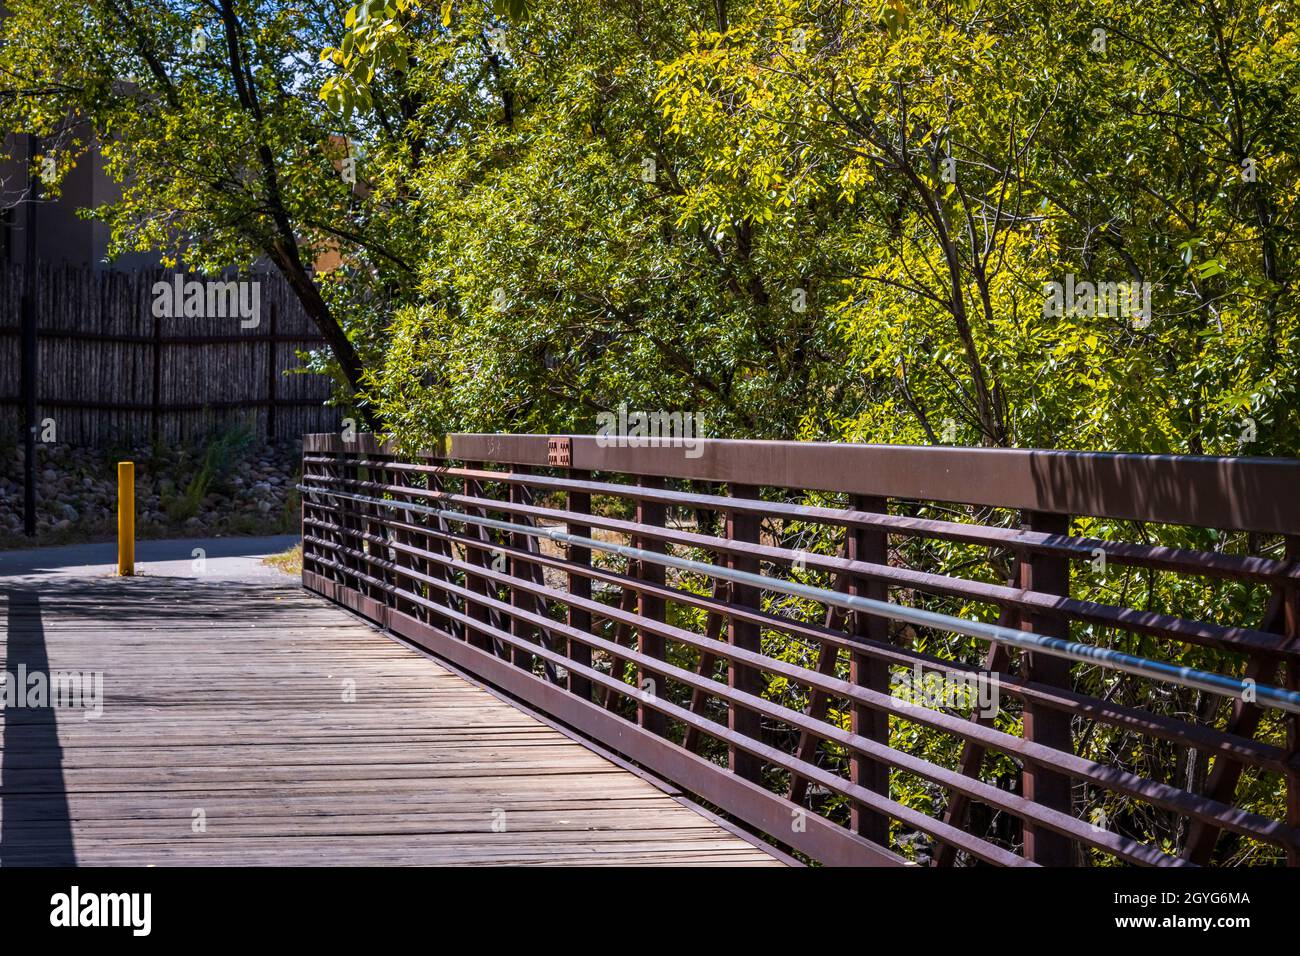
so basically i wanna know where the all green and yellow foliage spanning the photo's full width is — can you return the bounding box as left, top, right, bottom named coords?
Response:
left=0, top=0, right=1300, bottom=453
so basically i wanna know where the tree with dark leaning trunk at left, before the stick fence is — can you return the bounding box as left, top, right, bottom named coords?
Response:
left=0, top=0, right=426, bottom=415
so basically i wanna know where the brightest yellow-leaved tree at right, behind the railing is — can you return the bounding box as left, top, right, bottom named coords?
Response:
left=662, top=3, right=1297, bottom=453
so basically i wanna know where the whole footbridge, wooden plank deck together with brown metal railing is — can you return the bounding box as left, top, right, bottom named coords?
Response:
left=0, top=434, right=1300, bottom=866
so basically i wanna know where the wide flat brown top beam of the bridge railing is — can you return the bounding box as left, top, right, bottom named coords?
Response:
left=303, top=434, right=1300, bottom=535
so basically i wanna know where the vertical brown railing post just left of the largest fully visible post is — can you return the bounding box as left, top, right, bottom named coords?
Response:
left=845, top=496, right=889, bottom=847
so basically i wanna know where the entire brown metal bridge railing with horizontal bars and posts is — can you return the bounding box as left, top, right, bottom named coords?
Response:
left=302, top=434, right=1300, bottom=865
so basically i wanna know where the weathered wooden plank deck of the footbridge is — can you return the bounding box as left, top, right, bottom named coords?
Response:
left=0, top=564, right=777, bottom=866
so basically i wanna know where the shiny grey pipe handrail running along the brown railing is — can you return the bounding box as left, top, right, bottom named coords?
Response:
left=298, top=485, right=1300, bottom=714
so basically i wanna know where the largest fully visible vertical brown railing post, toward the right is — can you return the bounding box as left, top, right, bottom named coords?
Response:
left=1021, top=511, right=1074, bottom=866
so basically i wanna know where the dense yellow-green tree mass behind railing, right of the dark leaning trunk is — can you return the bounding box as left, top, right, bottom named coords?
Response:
left=328, top=0, right=1300, bottom=453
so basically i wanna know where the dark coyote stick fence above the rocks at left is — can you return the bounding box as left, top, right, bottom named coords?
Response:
left=0, top=265, right=341, bottom=445
